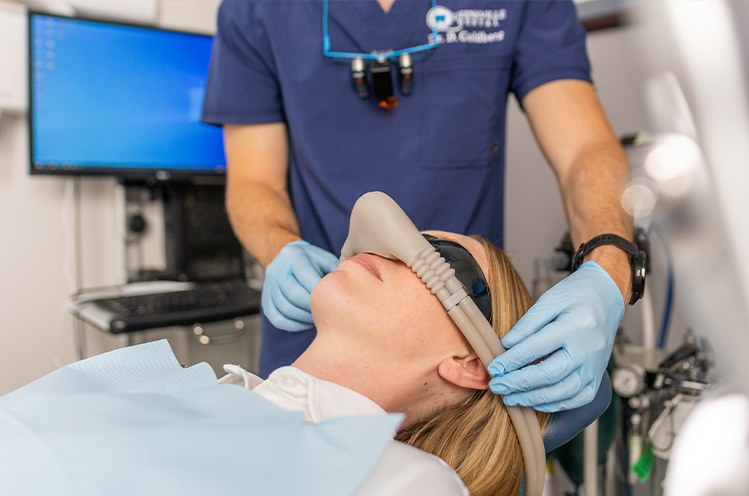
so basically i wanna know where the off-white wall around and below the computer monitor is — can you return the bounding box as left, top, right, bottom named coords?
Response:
left=0, top=0, right=219, bottom=394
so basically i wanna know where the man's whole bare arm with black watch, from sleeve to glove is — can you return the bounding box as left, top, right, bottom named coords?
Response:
left=523, top=80, right=633, bottom=301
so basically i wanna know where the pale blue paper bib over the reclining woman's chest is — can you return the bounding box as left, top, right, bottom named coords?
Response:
left=0, top=341, right=402, bottom=496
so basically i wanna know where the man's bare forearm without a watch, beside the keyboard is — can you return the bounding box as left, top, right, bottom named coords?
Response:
left=226, top=179, right=300, bottom=267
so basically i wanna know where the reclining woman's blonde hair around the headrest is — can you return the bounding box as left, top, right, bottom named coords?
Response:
left=396, top=236, right=548, bottom=496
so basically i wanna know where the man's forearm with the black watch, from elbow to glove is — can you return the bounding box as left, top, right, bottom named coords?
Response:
left=559, top=137, right=633, bottom=302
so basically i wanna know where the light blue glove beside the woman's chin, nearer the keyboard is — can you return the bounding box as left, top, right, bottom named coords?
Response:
left=261, top=240, right=338, bottom=332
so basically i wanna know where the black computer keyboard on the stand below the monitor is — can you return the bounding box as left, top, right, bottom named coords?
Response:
left=75, top=280, right=260, bottom=333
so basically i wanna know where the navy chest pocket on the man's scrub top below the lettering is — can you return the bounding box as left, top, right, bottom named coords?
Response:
left=414, top=55, right=511, bottom=169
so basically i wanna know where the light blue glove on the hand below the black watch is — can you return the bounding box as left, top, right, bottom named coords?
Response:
left=489, top=262, right=624, bottom=412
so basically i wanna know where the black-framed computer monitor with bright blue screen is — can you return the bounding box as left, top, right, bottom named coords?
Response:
left=28, top=12, right=226, bottom=180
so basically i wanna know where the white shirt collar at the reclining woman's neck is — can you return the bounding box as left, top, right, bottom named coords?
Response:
left=219, top=365, right=386, bottom=423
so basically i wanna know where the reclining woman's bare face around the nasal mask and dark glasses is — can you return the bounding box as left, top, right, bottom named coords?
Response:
left=312, top=231, right=487, bottom=362
